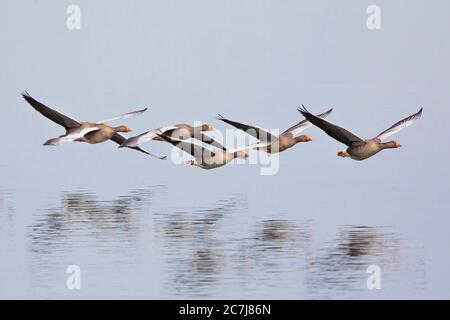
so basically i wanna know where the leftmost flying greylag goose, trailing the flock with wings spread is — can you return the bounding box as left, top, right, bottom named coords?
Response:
left=22, top=91, right=166, bottom=159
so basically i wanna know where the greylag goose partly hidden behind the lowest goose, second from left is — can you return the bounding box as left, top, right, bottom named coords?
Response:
left=119, top=123, right=214, bottom=148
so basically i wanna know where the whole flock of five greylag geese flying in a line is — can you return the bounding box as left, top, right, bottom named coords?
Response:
left=22, top=91, right=422, bottom=169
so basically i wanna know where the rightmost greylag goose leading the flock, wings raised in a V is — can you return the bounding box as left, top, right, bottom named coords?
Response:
left=298, top=105, right=422, bottom=160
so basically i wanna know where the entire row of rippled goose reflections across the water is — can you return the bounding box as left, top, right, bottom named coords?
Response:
left=23, top=187, right=425, bottom=299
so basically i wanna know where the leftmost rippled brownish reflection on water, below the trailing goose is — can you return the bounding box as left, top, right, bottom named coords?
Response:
left=28, top=189, right=158, bottom=253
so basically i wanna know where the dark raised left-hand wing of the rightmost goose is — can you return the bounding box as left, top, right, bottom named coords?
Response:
left=298, top=105, right=364, bottom=147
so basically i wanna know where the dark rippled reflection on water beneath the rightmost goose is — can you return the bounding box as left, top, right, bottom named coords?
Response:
left=305, top=226, right=424, bottom=298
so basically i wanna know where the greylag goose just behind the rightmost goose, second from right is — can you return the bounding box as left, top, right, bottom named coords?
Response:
left=217, top=109, right=333, bottom=153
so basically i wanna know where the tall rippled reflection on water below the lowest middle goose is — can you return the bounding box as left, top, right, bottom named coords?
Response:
left=154, top=195, right=247, bottom=296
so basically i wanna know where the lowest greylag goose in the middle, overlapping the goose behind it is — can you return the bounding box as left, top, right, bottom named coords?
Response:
left=157, top=133, right=252, bottom=170
